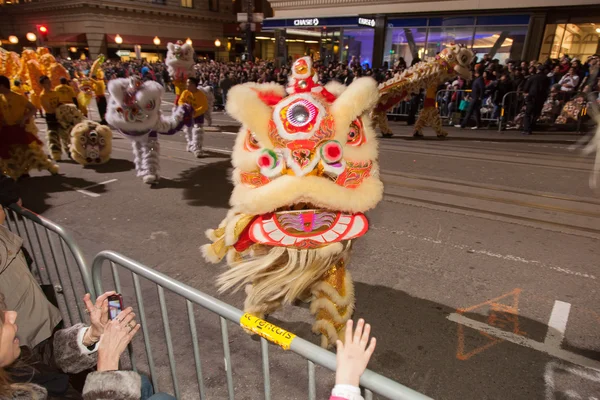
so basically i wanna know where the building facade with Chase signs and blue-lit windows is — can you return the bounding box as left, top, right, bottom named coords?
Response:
left=263, top=0, right=600, bottom=67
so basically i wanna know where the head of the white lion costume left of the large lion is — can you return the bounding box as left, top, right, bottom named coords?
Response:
left=106, top=77, right=164, bottom=133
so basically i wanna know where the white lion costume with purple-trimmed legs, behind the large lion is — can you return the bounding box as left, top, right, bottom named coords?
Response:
left=106, top=77, right=193, bottom=184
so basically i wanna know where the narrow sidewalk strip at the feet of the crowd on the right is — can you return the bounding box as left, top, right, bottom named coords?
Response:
left=377, top=121, right=595, bottom=144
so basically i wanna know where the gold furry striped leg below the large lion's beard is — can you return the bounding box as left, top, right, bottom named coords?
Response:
left=310, top=261, right=354, bottom=348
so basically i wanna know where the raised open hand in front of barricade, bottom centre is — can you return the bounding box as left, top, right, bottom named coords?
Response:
left=335, top=318, right=376, bottom=386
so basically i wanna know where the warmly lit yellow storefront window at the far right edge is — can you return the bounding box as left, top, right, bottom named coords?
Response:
left=539, top=21, right=600, bottom=62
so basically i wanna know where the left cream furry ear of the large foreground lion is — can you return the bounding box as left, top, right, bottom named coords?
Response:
left=225, top=83, right=285, bottom=143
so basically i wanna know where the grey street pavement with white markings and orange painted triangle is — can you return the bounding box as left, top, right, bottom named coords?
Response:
left=19, top=94, right=600, bottom=400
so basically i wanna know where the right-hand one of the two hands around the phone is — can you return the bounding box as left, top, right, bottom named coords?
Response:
left=97, top=307, right=140, bottom=372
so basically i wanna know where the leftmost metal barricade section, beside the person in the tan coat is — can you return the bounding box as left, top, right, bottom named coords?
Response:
left=4, top=204, right=94, bottom=326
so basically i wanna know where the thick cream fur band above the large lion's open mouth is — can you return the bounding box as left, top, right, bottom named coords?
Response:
left=230, top=168, right=383, bottom=215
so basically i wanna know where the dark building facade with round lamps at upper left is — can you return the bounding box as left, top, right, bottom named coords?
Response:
left=0, top=0, right=235, bottom=59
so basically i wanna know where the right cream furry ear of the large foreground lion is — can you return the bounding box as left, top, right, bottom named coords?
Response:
left=330, top=78, right=379, bottom=142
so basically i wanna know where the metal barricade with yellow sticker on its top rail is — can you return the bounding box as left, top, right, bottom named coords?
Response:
left=92, top=251, right=429, bottom=400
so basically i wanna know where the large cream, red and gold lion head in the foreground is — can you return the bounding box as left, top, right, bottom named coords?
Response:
left=227, top=57, right=383, bottom=247
